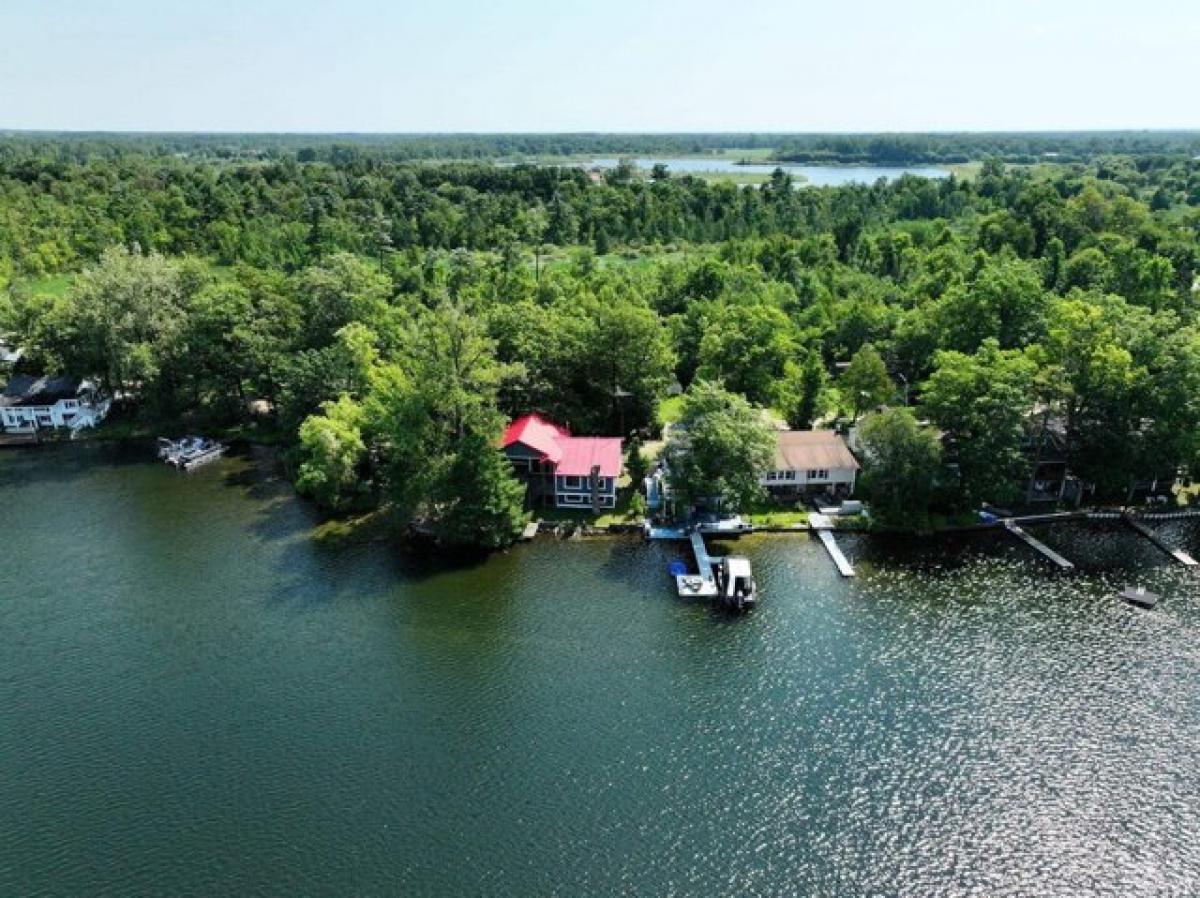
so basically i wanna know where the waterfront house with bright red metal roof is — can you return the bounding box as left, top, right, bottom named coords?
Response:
left=500, top=414, right=622, bottom=510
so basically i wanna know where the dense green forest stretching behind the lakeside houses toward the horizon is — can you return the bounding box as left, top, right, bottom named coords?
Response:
left=0, top=136, right=1200, bottom=545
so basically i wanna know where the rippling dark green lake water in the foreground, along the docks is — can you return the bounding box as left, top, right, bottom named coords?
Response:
left=0, top=445, right=1200, bottom=898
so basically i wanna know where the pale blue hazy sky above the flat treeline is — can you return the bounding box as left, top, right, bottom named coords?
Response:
left=0, top=0, right=1200, bottom=131
